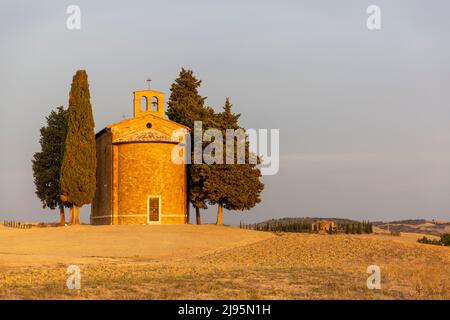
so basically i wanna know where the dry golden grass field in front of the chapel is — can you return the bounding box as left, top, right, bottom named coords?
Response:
left=0, top=225, right=450, bottom=299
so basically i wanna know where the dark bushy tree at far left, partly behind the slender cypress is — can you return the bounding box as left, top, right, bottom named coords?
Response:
left=32, top=106, right=67, bottom=225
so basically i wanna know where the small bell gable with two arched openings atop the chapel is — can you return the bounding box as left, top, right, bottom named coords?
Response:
left=133, top=90, right=164, bottom=118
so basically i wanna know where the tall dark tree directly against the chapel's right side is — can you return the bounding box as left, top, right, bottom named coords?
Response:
left=167, top=68, right=214, bottom=224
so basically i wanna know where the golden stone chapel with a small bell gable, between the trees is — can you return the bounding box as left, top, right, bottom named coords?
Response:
left=91, top=90, right=189, bottom=225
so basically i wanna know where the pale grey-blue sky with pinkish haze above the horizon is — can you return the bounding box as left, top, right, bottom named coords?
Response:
left=0, top=0, right=450, bottom=223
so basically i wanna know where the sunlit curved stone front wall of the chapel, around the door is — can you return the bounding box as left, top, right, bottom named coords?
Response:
left=117, top=143, right=187, bottom=224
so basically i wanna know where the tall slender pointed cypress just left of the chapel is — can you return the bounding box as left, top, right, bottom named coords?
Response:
left=61, top=70, right=97, bottom=224
